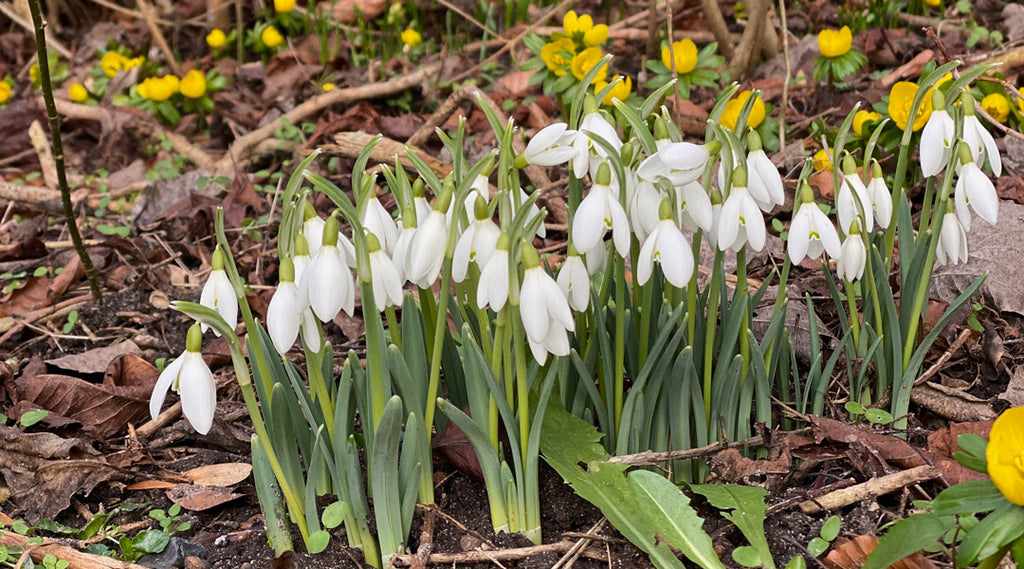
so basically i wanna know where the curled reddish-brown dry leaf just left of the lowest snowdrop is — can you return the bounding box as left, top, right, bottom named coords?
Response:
left=15, top=354, right=160, bottom=440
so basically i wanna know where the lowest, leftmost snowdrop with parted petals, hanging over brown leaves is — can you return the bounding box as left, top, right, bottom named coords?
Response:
left=150, top=324, right=217, bottom=435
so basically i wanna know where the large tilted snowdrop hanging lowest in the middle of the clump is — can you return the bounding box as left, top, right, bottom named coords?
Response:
left=520, top=240, right=575, bottom=365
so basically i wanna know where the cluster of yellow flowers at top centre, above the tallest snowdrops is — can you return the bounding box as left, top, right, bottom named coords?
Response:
left=541, top=10, right=608, bottom=84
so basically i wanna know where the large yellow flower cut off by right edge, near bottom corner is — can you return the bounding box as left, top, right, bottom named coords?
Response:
left=985, top=407, right=1024, bottom=506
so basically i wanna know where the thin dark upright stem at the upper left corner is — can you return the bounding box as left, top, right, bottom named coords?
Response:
left=29, top=0, right=102, bottom=302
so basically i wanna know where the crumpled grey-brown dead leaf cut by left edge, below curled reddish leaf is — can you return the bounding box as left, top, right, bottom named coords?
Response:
left=0, top=425, right=122, bottom=524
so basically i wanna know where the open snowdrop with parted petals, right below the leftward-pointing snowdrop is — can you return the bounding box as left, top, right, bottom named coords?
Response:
left=572, top=162, right=630, bottom=257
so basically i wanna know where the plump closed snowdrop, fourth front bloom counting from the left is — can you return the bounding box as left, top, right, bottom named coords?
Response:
left=299, top=216, right=355, bottom=322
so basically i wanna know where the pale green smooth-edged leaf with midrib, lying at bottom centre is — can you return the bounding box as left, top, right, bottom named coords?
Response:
left=629, top=470, right=724, bottom=567
